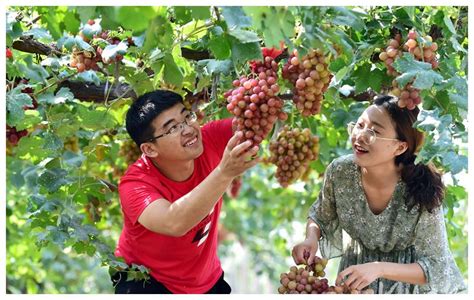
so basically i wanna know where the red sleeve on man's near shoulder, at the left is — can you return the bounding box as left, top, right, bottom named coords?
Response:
left=119, top=179, right=163, bottom=225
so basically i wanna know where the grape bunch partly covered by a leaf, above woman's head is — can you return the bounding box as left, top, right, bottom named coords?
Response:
left=379, top=30, right=439, bottom=110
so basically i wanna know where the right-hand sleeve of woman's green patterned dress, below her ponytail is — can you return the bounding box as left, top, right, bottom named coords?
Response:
left=415, top=207, right=467, bottom=294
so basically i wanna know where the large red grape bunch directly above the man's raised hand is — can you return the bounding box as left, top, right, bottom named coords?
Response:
left=224, top=56, right=288, bottom=145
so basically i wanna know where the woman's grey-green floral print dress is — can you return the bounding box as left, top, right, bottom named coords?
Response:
left=308, top=154, right=467, bottom=294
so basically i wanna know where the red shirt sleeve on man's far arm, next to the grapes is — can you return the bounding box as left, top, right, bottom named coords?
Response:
left=202, top=118, right=233, bottom=157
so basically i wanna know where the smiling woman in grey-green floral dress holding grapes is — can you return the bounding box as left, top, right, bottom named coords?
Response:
left=292, top=96, right=466, bottom=293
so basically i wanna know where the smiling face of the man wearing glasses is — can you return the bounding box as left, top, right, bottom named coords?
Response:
left=144, top=103, right=204, bottom=161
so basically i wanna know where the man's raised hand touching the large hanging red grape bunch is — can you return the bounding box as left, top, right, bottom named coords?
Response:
left=217, top=131, right=260, bottom=179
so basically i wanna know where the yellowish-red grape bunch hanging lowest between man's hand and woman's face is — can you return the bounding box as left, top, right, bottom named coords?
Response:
left=269, top=125, right=319, bottom=187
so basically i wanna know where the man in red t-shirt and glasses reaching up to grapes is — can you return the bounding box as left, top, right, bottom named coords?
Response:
left=112, top=90, right=259, bottom=294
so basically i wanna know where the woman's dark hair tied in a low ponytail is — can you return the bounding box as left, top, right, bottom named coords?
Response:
left=374, top=95, right=445, bottom=212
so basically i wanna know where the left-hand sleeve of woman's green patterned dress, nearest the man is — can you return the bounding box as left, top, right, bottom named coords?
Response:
left=308, top=162, right=343, bottom=259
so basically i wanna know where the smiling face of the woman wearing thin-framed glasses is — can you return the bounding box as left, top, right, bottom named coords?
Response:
left=351, top=105, right=406, bottom=167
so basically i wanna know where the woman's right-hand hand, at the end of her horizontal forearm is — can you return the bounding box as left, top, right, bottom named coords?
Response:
left=336, top=262, right=382, bottom=291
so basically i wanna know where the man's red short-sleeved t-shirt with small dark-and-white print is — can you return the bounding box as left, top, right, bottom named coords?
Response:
left=115, top=119, right=232, bottom=294
